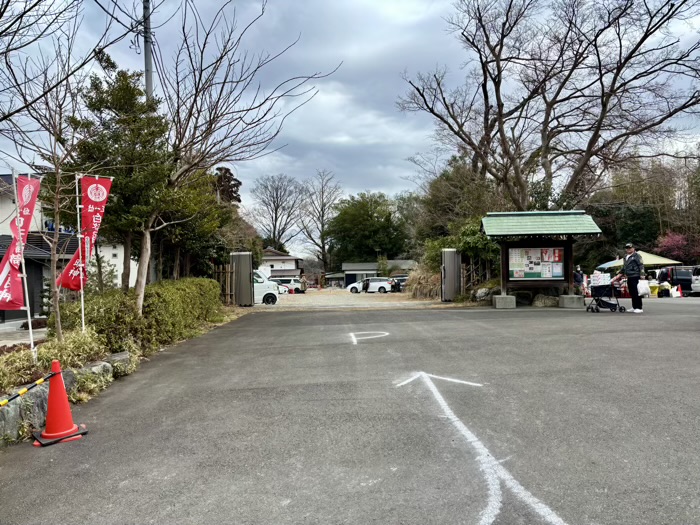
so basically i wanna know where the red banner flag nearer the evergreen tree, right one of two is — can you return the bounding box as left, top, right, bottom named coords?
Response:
left=56, top=177, right=112, bottom=290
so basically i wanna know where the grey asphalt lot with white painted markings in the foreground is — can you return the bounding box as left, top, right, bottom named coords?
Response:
left=0, top=299, right=700, bottom=525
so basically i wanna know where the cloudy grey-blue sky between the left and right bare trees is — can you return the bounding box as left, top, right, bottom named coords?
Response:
left=101, top=0, right=464, bottom=205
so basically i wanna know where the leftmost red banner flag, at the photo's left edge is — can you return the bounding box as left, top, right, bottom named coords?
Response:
left=0, top=177, right=41, bottom=310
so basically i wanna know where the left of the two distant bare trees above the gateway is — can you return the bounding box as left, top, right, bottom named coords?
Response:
left=251, top=173, right=304, bottom=250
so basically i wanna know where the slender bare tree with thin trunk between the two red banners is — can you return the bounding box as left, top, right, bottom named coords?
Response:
left=0, top=20, right=95, bottom=340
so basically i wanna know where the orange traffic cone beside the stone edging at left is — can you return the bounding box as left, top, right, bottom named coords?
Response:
left=34, top=359, right=87, bottom=447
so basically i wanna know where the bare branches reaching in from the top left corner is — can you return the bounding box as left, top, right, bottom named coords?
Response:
left=0, top=0, right=143, bottom=124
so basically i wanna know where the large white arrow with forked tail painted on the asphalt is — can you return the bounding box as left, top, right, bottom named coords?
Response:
left=396, top=372, right=566, bottom=525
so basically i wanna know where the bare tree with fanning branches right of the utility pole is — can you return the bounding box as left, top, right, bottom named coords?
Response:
left=130, top=0, right=334, bottom=311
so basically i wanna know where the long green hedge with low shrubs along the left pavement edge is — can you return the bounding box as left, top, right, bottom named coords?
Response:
left=0, top=278, right=222, bottom=393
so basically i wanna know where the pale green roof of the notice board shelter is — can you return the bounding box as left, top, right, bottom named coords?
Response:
left=481, top=210, right=601, bottom=237
